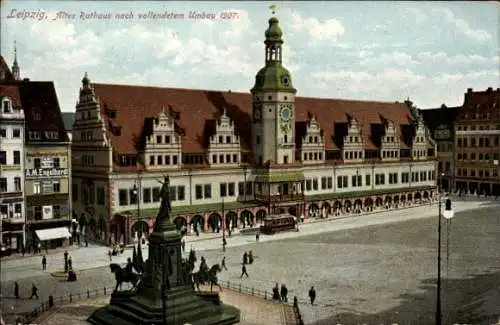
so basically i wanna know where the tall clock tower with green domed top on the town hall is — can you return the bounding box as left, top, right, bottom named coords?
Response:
left=251, top=17, right=297, bottom=164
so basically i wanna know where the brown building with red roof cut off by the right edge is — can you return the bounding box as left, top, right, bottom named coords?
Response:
left=455, top=88, right=500, bottom=196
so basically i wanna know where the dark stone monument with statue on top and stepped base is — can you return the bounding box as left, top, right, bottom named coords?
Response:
left=88, top=177, right=240, bottom=325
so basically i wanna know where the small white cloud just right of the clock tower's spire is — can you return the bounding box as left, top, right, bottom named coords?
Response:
left=291, top=12, right=345, bottom=41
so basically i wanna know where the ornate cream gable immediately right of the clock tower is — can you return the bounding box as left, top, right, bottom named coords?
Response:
left=299, top=113, right=325, bottom=164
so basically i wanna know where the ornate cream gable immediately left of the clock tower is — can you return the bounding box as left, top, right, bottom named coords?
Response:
left=208, top=108, right=241, bottom=165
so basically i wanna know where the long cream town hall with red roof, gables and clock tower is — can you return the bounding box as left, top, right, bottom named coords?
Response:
left=72, top=17, right=436, bottom=242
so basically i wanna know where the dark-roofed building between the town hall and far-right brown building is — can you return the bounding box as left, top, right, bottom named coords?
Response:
left=420, top=104, right=459, bottom=192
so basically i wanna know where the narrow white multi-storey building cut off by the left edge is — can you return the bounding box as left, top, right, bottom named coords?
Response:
left=0, top=57, right=25, bottom=250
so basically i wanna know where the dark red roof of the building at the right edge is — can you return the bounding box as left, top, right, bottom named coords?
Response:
left=457, top=88, right=500, bottom=122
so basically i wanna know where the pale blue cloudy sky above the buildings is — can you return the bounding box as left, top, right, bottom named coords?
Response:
left=0, top=0, right=500, bottom=112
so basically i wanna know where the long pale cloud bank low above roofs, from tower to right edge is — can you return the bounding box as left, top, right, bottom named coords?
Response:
left=310, top=68, right=498, bottom=108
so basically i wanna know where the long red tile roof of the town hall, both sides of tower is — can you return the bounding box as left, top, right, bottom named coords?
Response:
left=92, top=83, right=413, bottom=154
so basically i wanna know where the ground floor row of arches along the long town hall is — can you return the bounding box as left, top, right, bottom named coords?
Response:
left=108, top=188, right=437, bottom=243
